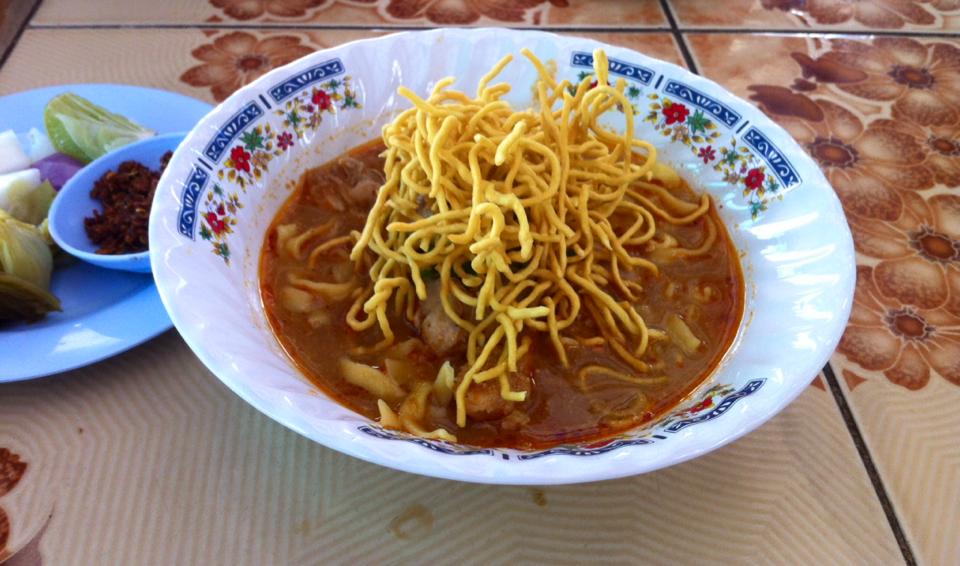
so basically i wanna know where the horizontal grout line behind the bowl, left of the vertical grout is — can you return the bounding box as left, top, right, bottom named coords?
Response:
left=30, top=23, right=671, bottom=34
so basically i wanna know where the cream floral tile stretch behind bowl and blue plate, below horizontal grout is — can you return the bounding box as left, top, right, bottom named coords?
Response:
left=0, top=29, right=683, bottom=106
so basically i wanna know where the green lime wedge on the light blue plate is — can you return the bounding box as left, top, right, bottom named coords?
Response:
left=43, top=92, right=156, bottom=163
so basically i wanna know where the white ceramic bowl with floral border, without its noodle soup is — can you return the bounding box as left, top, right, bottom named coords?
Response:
left=150, top=29, right=854, bottom=484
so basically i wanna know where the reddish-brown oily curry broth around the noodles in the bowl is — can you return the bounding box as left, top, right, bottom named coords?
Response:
left=260, top=141, right=744, bottom=448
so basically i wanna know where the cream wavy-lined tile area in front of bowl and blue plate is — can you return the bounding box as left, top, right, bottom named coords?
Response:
left=0, top=332, right=899, bottom=565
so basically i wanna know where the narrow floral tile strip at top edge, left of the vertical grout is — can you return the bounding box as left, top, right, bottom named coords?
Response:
left=35, top=0, right=667, bottom=28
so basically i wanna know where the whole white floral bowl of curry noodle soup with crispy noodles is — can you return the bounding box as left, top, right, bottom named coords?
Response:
left=150, top=29, right=854, bottom=484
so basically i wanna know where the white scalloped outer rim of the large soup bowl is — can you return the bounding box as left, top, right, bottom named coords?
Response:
left=150, top=28, right=855, bottom=485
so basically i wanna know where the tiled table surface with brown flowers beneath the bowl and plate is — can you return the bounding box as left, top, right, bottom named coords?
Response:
left=0, top=0, right=960, bottom=564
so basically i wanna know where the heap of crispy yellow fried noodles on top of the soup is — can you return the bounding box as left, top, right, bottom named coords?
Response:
left=347, top=50, right=717, bottom=440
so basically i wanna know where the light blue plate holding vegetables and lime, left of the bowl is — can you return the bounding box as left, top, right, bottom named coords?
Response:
left=0, top=84, right=212, bottom=383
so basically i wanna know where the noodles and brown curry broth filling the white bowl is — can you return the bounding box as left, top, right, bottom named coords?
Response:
left=262, top=50, right=742, bottom=446
